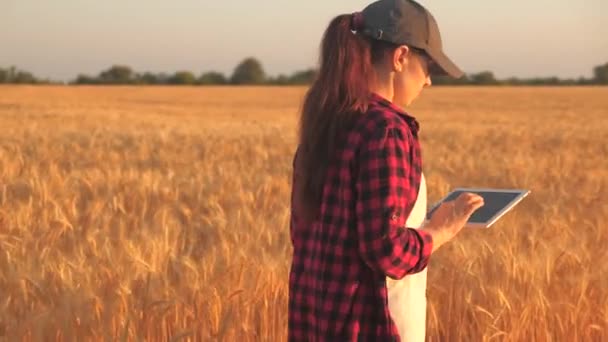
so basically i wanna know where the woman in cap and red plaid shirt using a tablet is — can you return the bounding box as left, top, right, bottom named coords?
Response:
left=288, top=0, right=483, bottom=341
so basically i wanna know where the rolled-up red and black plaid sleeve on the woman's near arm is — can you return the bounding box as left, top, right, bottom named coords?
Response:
left=356, top=124, right=433, bottom=279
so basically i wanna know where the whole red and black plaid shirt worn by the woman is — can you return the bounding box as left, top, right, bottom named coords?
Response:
left=288, top=94, right=433, bottom=342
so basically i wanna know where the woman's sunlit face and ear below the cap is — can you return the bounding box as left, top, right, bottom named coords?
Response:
left=393, top=46, right=432, bottom=107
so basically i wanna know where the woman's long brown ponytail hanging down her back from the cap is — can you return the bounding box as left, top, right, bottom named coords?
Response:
left=295, top=15, right=395, bottom=219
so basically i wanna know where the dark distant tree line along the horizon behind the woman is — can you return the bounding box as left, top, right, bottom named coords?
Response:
left=0, top=57, right=608, bottom=86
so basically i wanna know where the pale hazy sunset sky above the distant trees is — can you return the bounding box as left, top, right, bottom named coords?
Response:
left=0, top=0, right=608, bottom=81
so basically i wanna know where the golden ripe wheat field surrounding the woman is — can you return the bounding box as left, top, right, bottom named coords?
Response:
left=0, top=86, right=608, bottom=341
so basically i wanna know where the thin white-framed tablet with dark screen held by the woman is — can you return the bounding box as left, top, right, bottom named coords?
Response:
left=426, top=188, right=530, bottom=228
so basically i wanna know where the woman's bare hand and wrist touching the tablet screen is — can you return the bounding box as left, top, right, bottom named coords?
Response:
left=421, top=192, right=484, bottom=252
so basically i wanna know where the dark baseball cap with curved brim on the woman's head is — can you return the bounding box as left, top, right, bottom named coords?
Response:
left=360, top=0, right=464, bottom=78
